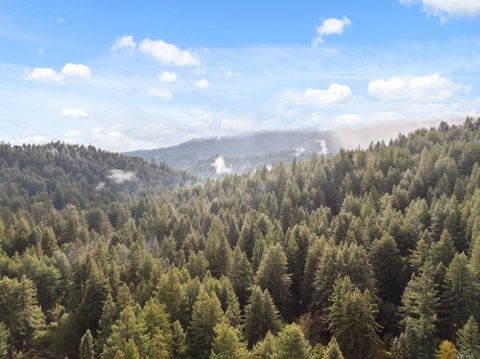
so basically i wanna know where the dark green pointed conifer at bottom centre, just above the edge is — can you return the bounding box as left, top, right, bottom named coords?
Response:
left=244, top=286, right=280, bottom=348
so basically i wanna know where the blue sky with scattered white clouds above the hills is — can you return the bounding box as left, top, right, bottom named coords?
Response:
left=0, top=0, right=480, bottom=151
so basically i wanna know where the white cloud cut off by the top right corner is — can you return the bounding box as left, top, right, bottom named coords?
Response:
left=400, top=0, right=480, bottom=20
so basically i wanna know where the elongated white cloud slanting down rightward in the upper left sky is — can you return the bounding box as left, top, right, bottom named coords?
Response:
left=140, top=39, right=200, bottom=66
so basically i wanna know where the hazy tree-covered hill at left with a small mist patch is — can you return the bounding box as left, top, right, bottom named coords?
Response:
left=0, top=142, right=191, bottom=210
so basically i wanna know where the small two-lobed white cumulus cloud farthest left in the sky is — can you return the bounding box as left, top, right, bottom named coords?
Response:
left=24, top=63, right=92, bottom=85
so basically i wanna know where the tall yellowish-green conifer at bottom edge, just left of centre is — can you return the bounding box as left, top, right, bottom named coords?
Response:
left=187, top=290, right=223, bottom=359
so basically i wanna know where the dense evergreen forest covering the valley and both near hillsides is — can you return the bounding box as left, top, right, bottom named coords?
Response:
left=0, top=119, right=480, bottom=359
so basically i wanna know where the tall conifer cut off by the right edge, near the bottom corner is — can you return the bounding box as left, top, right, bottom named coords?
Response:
left=440, top=253, right=480, bottom=338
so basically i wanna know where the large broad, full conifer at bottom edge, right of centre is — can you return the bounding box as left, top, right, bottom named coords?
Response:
left=327, top=276, right=380, bottom=359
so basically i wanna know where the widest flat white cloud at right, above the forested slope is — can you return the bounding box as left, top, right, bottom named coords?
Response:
left=368, top=73, right=469, bottom=101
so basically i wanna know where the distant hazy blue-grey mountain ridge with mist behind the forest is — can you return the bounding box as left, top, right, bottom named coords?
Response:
left=125, top=120, right=454, bottom=177
